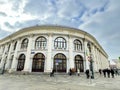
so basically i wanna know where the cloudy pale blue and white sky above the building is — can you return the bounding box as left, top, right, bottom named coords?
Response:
left=0, top=0, right=120, bottom=59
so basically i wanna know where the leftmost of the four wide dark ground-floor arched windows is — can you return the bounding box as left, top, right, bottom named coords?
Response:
left=17, top=54, right=25, bottom=71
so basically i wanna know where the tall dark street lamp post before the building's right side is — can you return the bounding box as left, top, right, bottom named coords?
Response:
left=87, top=43, right=94, bottom=79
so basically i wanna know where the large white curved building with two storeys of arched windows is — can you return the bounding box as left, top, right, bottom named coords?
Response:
left=0, top=25, right=109, bottom=73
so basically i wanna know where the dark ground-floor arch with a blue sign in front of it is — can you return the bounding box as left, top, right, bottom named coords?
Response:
left=54, top=53, right=67, bottom=72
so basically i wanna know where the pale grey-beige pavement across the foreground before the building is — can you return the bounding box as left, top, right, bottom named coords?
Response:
left=0, top=74, right=120, bottom=90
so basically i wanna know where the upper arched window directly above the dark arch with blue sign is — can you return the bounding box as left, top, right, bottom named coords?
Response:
left=54, top=37, right=67, bottom=49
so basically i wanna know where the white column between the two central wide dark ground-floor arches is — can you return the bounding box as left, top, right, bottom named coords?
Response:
left=44, top=34, right=53, bottom=72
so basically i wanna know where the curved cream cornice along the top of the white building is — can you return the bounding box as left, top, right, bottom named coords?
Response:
left=0, top=25, right=107, bottom=55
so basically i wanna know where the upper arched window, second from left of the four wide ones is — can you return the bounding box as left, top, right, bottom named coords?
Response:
left=35, top=36, right=47, bottom=49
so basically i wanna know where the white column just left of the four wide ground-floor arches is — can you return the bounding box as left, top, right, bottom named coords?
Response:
left=10, top=40, right=21, bottom=72
